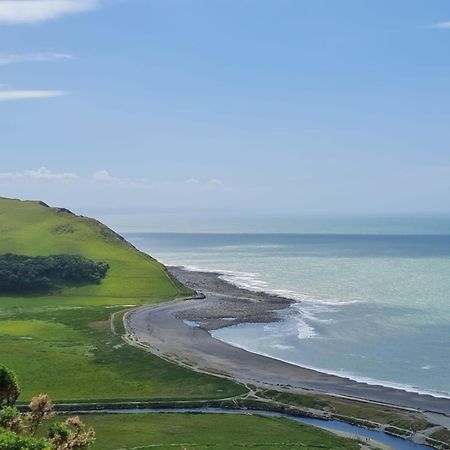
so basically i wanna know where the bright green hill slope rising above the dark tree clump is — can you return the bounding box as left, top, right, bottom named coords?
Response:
left=0, top=198, right=191, bottom=303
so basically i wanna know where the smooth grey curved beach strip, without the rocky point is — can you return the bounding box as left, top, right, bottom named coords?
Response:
left=124, top=294, right=450, bottom=416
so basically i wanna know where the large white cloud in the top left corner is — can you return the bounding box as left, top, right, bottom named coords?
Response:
left=0, top=0, right=100, bottom=24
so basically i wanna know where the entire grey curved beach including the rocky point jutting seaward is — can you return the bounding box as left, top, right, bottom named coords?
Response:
left=126, top=267, right=450, bottom=416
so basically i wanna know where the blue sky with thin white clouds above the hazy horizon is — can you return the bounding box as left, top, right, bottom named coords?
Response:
left=0, top=0, right=450, bottom=214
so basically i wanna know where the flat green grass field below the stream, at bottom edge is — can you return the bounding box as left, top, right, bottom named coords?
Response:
left=44, top=413, right=359, bottom=450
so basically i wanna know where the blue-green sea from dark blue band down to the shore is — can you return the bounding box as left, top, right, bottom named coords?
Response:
left=126, top=233, right=450, bottom=396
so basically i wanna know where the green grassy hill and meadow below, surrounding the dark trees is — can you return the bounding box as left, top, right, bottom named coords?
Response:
left=0, top=198, right=243, bottom=400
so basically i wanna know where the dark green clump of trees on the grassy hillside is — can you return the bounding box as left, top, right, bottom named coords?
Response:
left=0, top=253, right=109, bottom=293
